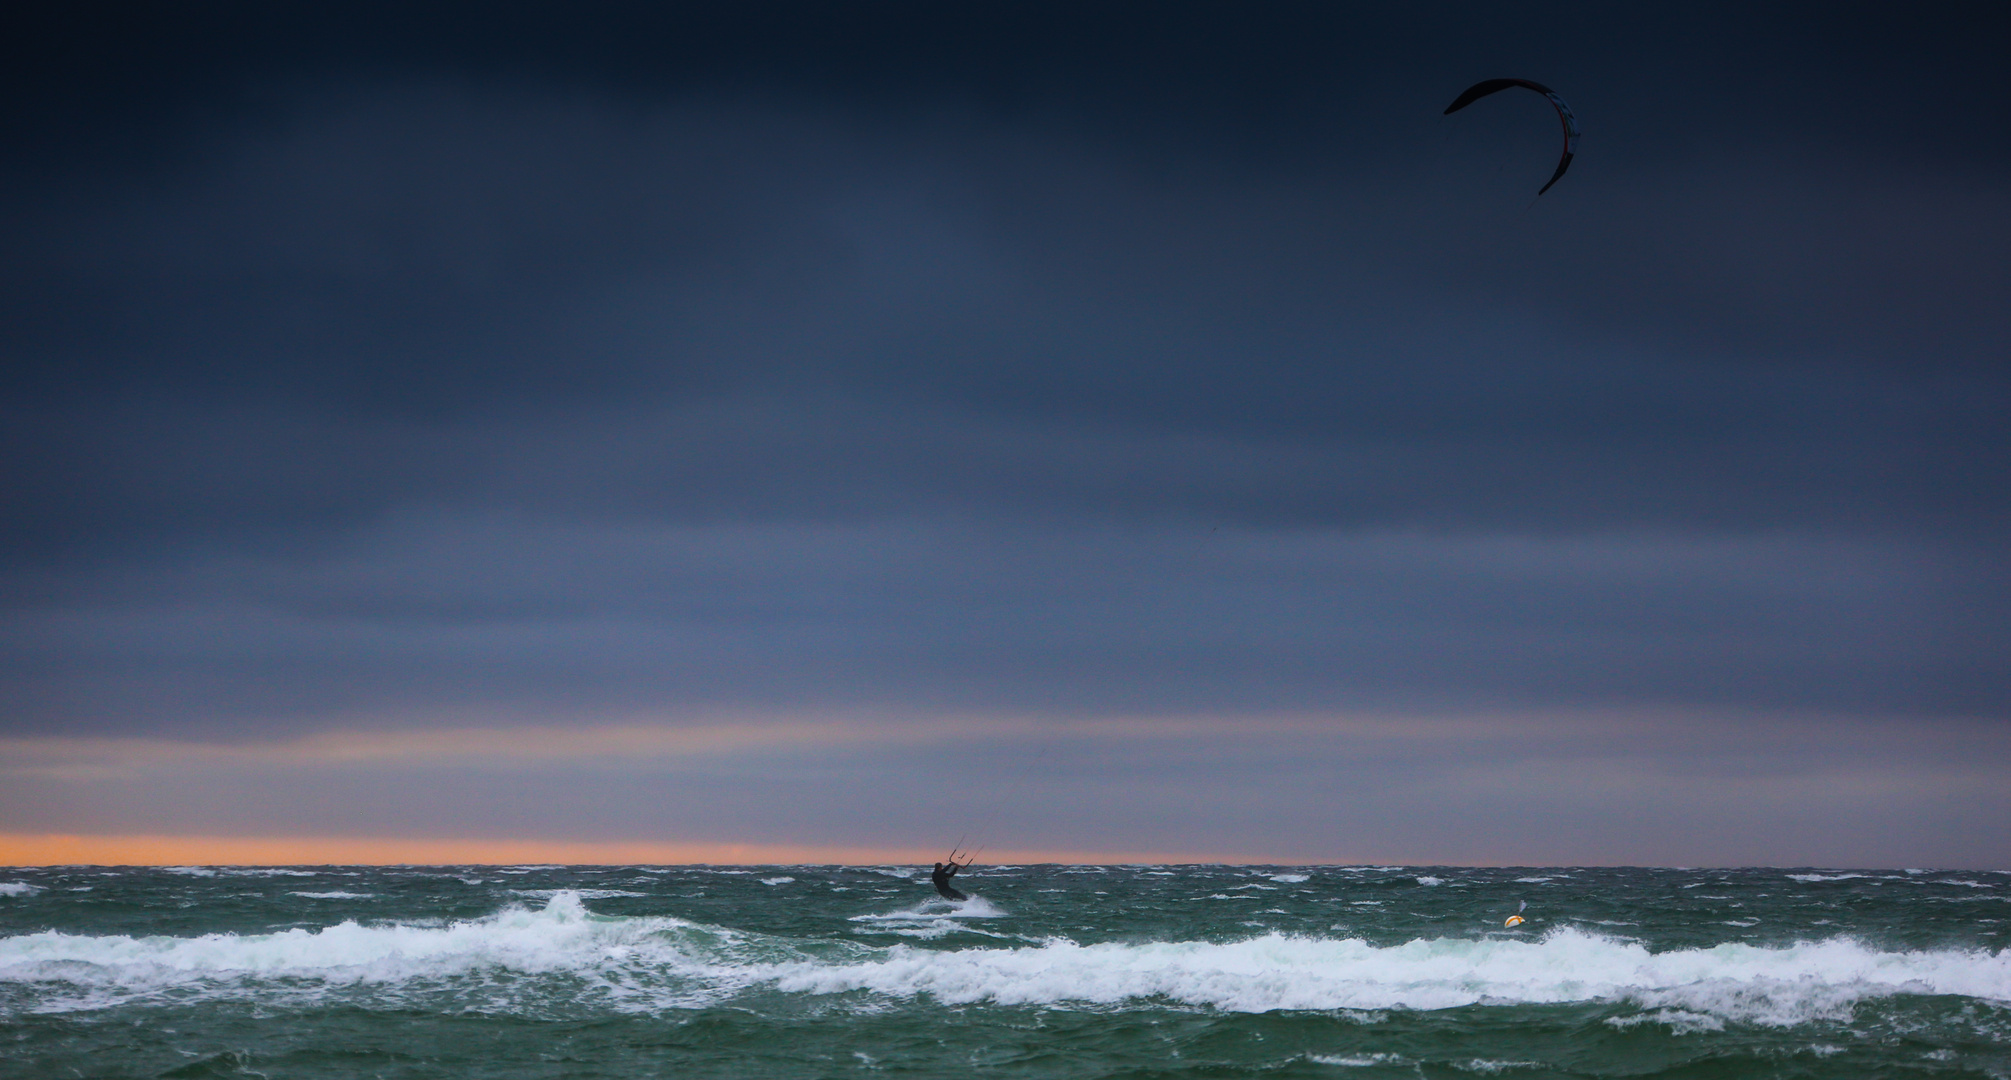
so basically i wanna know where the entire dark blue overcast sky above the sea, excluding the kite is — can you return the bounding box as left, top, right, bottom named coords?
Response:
left=0, top=2, right=2011, bottom=867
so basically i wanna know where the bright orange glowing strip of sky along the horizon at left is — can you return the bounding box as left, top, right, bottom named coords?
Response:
left=0, top=833, right=1269, bottom=867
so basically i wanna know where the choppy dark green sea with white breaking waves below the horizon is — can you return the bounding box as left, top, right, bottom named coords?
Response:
left=0, top=865, right=2011, bottom=1078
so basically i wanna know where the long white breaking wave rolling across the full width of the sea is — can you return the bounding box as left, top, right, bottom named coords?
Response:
left=0, top=891, right=2011, bottom=1026
